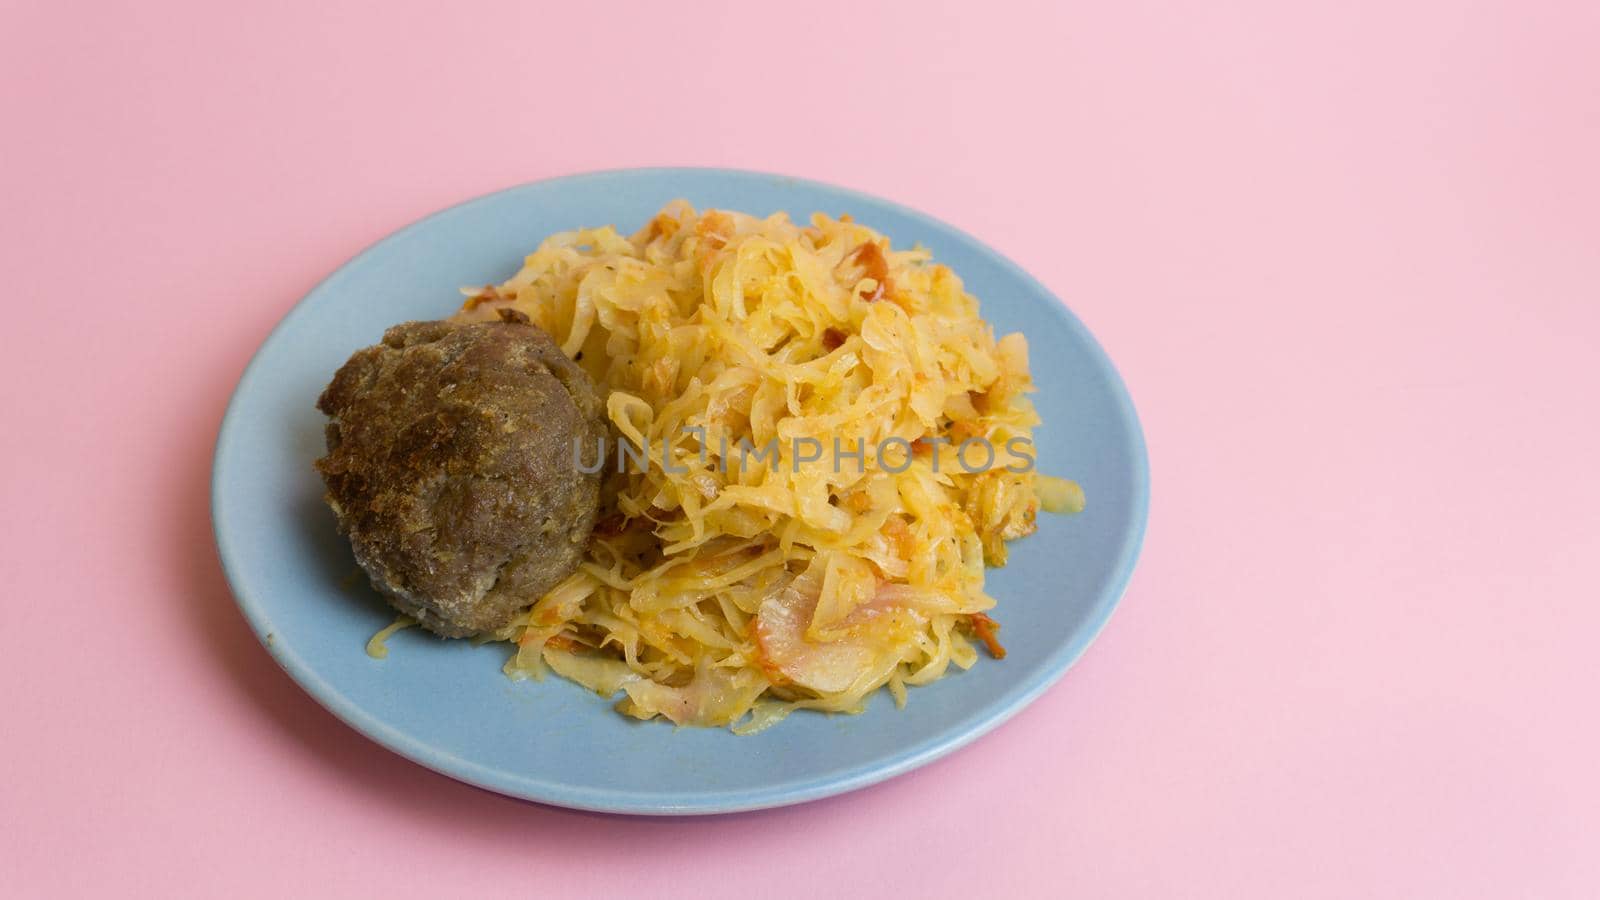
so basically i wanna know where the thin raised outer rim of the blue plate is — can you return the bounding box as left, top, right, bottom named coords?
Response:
left=210, top=167, right=1150, bottom=815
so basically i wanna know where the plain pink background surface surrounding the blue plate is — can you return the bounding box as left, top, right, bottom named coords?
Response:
left=0, top=0, right=1600, bottom=898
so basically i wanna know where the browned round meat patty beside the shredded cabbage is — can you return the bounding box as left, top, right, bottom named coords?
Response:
left=317, top=311, right=605, bottom=637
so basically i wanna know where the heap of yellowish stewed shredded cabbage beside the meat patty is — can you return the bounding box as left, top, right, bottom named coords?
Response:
left=458, top=200, right=1082, bottom=733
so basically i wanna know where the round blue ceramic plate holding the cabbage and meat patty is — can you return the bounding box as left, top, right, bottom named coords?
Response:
left=211, top=168, right=1149, bottom=814
